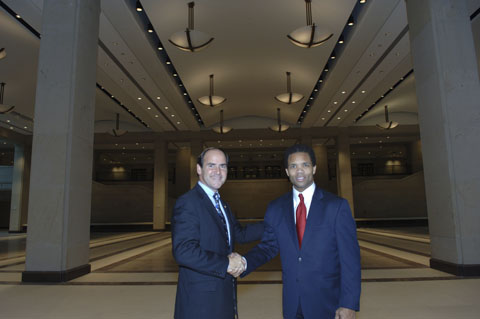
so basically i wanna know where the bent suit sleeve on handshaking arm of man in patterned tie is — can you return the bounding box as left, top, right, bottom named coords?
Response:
left=172, top=197, right=229, bottom=278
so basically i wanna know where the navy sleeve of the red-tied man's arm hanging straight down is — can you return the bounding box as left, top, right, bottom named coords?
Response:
left=335, top=200, right=361, bottom=311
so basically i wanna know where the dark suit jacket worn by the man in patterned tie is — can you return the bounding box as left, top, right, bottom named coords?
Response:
left=172, top=184, right=263, bottom=319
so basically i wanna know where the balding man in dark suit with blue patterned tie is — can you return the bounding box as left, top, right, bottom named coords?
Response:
left=172, top=148, right=263, bottom=319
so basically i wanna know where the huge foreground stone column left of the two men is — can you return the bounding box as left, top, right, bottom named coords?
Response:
left=22, top=0, right=100, bottom=282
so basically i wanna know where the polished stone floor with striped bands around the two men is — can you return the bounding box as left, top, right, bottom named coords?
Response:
left=0, top=227, right=480, bottom=319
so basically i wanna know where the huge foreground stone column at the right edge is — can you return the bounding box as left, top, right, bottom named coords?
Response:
left=406, top=0, right=480, bottom=276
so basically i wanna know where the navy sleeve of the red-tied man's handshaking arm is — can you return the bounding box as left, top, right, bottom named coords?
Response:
left=241, top=205, right=279, bottom=277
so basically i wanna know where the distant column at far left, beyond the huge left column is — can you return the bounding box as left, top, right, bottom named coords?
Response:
left=8, top=144, right=25, bottom=233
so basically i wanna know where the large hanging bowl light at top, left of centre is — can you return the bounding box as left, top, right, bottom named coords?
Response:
left=168, top=1, right=213, bottom=52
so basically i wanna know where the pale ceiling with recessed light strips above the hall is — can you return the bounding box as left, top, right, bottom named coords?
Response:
left=0, top=0, right=480, bottom=146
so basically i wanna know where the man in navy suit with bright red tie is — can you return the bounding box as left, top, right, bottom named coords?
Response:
left=242, top=144, right=361, bottom=319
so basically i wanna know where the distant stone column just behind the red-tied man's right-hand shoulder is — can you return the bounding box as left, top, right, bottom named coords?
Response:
left=337, top=128, right=355, bottom=216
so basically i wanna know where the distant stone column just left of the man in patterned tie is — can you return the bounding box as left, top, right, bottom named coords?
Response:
left=153, top=140, right=168, bottom=230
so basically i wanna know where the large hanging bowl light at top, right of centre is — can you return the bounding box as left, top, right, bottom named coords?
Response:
left=287, top=0, right=333, bottom=48
